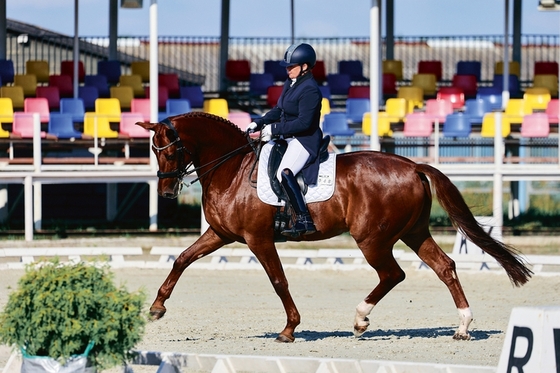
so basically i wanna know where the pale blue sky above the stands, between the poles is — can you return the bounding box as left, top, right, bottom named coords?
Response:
left=6, top=0, right=560, bottom=37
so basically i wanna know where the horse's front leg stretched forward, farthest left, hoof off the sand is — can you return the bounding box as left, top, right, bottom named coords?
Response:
left=150, top=228, right=228, bottom=320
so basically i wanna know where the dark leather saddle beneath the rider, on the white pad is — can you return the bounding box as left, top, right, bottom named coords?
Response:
left=268, top=135, right=331, bottom=201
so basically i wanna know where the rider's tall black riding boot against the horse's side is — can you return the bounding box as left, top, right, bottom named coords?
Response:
left=282, top=169, right=317, bottom=237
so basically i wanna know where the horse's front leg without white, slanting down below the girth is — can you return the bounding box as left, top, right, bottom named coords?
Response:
left=249, top=242, right=300, bottom=342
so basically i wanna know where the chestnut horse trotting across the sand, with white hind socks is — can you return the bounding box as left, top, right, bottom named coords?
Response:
left=137, top=112, right=532, bottom=342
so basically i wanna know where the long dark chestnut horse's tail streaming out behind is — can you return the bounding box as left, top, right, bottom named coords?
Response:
left=416, top=164, right=533, bottom=286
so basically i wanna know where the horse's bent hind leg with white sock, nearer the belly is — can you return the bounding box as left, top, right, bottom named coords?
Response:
left=354, top=242, right=405, bottom=337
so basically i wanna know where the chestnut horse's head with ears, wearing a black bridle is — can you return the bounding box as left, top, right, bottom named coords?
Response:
left=136, top=120, right=192, bottom=198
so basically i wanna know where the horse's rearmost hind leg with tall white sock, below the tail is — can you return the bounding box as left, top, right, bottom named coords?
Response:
left=402, top=235, right=473, bottom=340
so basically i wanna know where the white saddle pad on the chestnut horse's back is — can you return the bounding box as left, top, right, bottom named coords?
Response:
left=257, top=143, right=336, bottom=206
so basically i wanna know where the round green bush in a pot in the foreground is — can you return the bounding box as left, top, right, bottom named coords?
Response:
left=0, top=260, right=147, bottom=369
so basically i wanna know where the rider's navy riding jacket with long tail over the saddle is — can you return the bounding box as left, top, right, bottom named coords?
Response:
left=255, top=72, right=323, bottom=185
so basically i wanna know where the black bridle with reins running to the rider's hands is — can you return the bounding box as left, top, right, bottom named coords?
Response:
left=152, top=118, right=255, bottom=188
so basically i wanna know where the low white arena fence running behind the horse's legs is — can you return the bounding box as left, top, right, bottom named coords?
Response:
left=0, top=246, right=560, bottom=275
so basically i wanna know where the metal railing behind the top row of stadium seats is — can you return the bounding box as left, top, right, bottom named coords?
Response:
left=6, top=32, right=560, bottom=92
